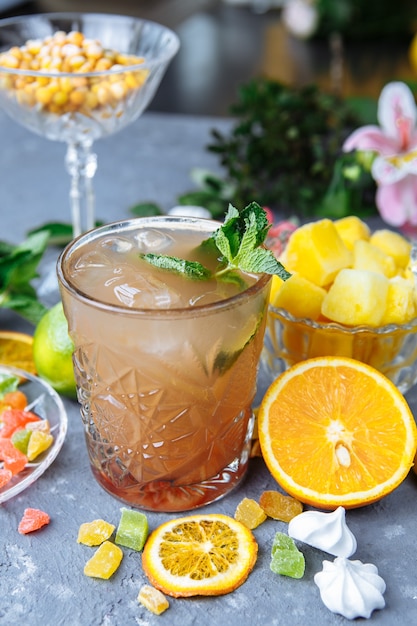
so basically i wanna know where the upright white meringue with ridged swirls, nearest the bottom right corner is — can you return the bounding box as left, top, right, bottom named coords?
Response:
left=314, top=557, right=386, bottom=619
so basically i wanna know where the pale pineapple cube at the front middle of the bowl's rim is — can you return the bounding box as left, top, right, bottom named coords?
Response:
left=321, top=268, right=389, bottom=326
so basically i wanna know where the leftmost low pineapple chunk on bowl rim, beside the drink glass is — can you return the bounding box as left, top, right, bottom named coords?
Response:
left=272, top=274, right=327, bottom=320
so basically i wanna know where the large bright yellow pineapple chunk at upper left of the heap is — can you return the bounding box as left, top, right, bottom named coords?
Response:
left=284, top=219, right=352, bottom=287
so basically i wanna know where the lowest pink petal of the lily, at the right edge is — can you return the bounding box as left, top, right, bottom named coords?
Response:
left=376, top=176, right=417, bottom=226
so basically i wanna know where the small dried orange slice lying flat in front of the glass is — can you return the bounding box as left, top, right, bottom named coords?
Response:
left=142, top=513, right=258, bottom=598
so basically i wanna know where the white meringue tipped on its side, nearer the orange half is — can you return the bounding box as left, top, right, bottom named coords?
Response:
left=288, top=506, right=357, bottom=557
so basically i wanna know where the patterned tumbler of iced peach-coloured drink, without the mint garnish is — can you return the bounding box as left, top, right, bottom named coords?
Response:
left=58, top=217, right=270, bottom=511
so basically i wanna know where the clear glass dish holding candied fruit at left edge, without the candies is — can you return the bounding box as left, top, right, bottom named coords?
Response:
left=0, top=365, right=68, bottom=504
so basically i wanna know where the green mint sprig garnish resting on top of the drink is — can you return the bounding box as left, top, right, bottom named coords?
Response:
left=141, top=202, right=291, bottom=280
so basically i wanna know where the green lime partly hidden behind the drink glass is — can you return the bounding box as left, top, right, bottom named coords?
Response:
left=33, top=302, right=76, bottom=397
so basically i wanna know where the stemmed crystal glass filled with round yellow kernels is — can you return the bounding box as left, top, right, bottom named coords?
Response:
left=0, top=13, right=179, bottom=237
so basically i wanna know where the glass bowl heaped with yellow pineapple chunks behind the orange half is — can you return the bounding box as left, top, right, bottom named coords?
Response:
left=261, top=216, right=417, bottom=393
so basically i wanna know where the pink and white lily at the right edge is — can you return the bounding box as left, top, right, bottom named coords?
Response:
left=343, top=82, right=417, bottom=226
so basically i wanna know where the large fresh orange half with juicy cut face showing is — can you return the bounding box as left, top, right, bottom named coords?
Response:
left=258, top=357, right=417, bottom=509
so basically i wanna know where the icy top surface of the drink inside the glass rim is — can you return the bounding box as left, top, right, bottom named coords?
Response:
left=69, top=222, right=257, bottom=309
